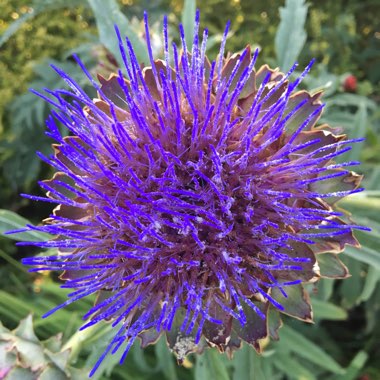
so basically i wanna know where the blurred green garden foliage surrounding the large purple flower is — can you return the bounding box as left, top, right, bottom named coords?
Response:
left=0, top=0, right=380, bottom=380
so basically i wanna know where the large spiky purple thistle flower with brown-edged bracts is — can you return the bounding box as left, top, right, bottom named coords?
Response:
left=19, top=12, right=363, bottom=373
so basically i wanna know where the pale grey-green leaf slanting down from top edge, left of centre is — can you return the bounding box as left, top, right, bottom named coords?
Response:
left=88, top=0, right=149, bottom=67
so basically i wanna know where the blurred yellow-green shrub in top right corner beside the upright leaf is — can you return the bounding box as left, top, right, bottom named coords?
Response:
left=308, top=0, right=380, bottom=84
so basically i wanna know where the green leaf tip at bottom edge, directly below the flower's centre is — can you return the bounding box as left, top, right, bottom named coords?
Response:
left=195, top=350, right=230, bottom=380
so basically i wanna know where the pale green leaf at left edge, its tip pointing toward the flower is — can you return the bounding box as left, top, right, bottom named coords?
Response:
left=0, top=210, right=52, bottom=241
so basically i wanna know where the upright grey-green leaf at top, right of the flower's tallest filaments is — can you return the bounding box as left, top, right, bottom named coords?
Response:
left=275, top=0, right=308, bottom=72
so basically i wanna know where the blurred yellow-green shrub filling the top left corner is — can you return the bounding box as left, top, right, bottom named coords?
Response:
left=0, top=0, right=88, bottom=112
